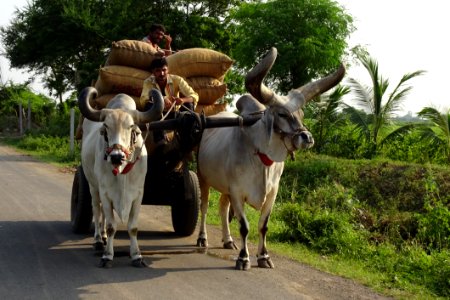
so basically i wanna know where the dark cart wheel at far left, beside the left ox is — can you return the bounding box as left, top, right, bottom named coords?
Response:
left=70, top=166, right=92, bottom=233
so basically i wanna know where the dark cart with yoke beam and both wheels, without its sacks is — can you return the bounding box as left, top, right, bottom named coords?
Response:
left=70, top=108, right=261, bottom=236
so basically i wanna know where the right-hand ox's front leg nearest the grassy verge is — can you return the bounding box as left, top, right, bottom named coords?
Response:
left=257, top=192, right=276, bottom=268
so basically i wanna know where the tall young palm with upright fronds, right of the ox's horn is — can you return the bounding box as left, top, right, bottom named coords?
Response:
left=349, top=52, right=425, bottom=158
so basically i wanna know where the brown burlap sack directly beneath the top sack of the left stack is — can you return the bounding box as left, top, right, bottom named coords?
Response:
left=95, top=65, right=151, bottom=97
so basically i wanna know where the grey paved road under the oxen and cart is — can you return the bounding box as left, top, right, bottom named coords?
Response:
left=0, top=144, right=385, bottom=300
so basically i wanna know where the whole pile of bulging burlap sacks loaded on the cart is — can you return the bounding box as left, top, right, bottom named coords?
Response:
left=76, top=40, right=233, bottom=139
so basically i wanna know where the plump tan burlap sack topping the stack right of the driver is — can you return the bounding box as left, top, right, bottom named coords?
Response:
left=167, top=48, right=233, bottom=78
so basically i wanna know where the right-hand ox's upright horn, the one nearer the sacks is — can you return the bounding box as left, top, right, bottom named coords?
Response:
left=245, top=47, right=277, bottom=104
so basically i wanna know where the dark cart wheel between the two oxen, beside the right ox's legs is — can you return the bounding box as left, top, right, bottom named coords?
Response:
left=172, top=170, right=200, bottom=236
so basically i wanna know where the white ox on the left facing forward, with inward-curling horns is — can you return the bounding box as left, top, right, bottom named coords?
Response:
left=78, top=87, right=163, bottom=268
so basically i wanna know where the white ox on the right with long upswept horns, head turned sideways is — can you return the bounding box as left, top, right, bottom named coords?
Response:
left=197, top=48, right=345, bottom=270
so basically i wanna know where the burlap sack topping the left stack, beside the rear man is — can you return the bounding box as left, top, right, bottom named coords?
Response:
left=105, top=40, right=158, bottom=70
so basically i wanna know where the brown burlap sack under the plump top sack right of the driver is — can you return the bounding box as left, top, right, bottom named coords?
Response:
left=186, top=77, right=227, bottom=105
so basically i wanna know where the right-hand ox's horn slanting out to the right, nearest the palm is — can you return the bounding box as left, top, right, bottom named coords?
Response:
left=295, top=64, right=345, bottom=104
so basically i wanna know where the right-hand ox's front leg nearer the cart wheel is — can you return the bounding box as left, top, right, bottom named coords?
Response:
left=232, top=200, right=251, bottom=271
